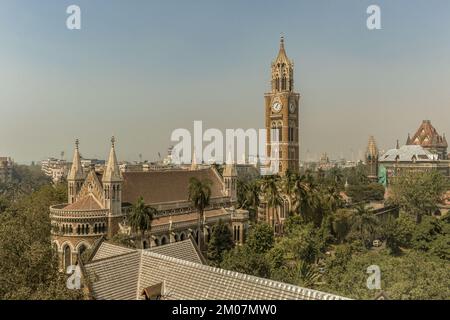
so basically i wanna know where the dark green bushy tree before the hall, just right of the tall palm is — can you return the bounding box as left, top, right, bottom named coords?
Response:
left=207, top=220, right=234, bottom=266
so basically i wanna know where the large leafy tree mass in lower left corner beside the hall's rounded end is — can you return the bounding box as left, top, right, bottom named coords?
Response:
left=0, top=185, right=82, bottom=299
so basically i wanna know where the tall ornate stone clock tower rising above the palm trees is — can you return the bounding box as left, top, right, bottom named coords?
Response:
left=264, top=37, right=300, bottom=175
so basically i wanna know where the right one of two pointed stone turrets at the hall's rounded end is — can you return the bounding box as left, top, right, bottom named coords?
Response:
left=102, top=137, right=123, bottom=237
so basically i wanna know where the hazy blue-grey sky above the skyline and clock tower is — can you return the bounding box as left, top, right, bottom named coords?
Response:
left=0, top=0, right=450, bottom=162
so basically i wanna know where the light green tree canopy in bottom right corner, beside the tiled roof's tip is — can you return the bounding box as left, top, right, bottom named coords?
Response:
left=317, top=249, right=450, bottom=299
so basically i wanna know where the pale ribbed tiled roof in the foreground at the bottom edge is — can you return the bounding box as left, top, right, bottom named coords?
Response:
left=84, top=244, right=346, bottom=300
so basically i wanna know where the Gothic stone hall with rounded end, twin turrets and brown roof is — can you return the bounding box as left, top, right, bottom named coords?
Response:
left=50, top=139, right=248, bottom=270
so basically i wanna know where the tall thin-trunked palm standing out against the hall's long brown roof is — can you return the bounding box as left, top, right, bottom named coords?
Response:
left=189, top=177, right=211, bottom=250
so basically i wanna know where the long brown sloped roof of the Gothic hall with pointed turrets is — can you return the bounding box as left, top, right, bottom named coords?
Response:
left=122, top=168, right=223, bottom=204
